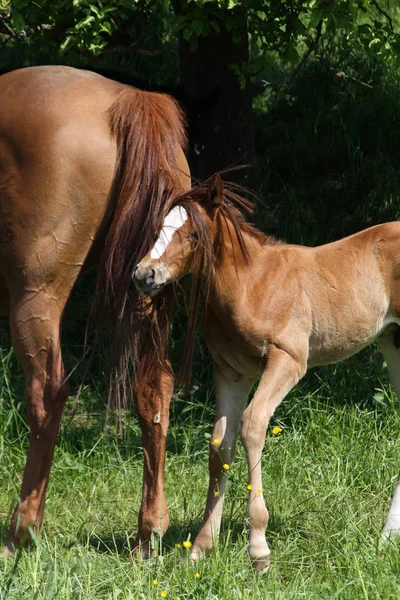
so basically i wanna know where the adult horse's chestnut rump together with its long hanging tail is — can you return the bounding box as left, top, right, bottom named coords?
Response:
left=0, top=67, right=190, bottom=404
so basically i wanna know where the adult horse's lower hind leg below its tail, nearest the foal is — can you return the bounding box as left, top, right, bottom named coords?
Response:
left=135, top=363, right=174, bottom=558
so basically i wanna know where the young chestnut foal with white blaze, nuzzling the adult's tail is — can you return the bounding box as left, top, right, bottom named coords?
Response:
left=133, top=177, right=400, bottom=569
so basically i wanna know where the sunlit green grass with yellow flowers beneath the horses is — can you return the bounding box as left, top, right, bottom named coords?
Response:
left=0, top=336, right=400, bottom=600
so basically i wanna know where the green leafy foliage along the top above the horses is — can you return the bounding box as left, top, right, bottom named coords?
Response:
left=0, top=0, right=400, bottom=75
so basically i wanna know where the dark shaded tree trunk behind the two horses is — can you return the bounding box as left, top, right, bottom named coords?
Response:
left=179, top=11, right=256, bottom=187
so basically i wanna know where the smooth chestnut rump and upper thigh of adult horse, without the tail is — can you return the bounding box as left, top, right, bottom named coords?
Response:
left=0, top=66, right=126, bottom=272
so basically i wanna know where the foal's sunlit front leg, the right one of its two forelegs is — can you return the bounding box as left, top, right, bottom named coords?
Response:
left=241, top=344, right=306, bottom=570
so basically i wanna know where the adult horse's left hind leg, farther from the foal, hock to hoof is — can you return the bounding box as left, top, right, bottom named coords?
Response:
left=1, top=288, right=68, bottom=551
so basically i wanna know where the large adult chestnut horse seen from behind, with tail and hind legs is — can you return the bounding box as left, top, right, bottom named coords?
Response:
left=0, top=66, right=190, bottom=556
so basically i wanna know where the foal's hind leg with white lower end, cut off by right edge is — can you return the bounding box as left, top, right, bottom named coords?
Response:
left=377, top=328, right=400, bottom=539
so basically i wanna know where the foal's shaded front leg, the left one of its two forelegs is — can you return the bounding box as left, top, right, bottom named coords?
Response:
left=191, top=363, right=253, bottom=558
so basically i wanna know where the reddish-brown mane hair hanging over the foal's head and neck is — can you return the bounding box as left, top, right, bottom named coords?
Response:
left=167, top=171, right=282, bottom=385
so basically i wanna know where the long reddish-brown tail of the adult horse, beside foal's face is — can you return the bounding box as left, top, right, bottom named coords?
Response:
left=98, top=88, right=188, bottom=406
